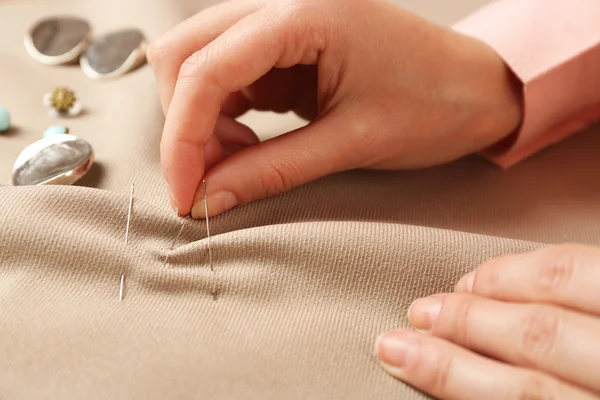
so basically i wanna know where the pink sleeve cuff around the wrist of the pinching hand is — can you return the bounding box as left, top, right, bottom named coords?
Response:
left=454, top=0, right=600, bottom=168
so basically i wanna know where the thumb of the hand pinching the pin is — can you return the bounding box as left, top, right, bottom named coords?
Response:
left=192, top=113, right=355, bottom=219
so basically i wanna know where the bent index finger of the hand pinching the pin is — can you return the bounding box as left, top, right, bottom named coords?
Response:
left=161, top=4, right=318, bottom=215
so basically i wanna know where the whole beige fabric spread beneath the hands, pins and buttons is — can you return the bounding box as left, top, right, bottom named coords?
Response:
left=0, top=0, right=600, bottom=399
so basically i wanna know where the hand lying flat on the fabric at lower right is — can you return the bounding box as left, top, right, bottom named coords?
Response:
left=377, top=245, right=600, bottom=400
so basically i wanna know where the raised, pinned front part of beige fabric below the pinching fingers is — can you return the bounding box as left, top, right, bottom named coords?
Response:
left=0, top=187, right=539, bottom=400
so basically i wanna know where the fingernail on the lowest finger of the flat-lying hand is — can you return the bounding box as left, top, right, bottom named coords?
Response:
left=375, top=331, right=418, bottom=376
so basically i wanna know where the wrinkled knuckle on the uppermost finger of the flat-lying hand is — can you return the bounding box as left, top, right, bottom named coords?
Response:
left=537, top=245, right=578, bottom=297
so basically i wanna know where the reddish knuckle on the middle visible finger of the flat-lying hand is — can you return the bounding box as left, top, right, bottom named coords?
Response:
left=522, top=306, right=562, bottom=365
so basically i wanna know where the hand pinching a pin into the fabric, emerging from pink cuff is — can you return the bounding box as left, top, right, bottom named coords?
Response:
left=148, top=0, right=521, bottom=218
